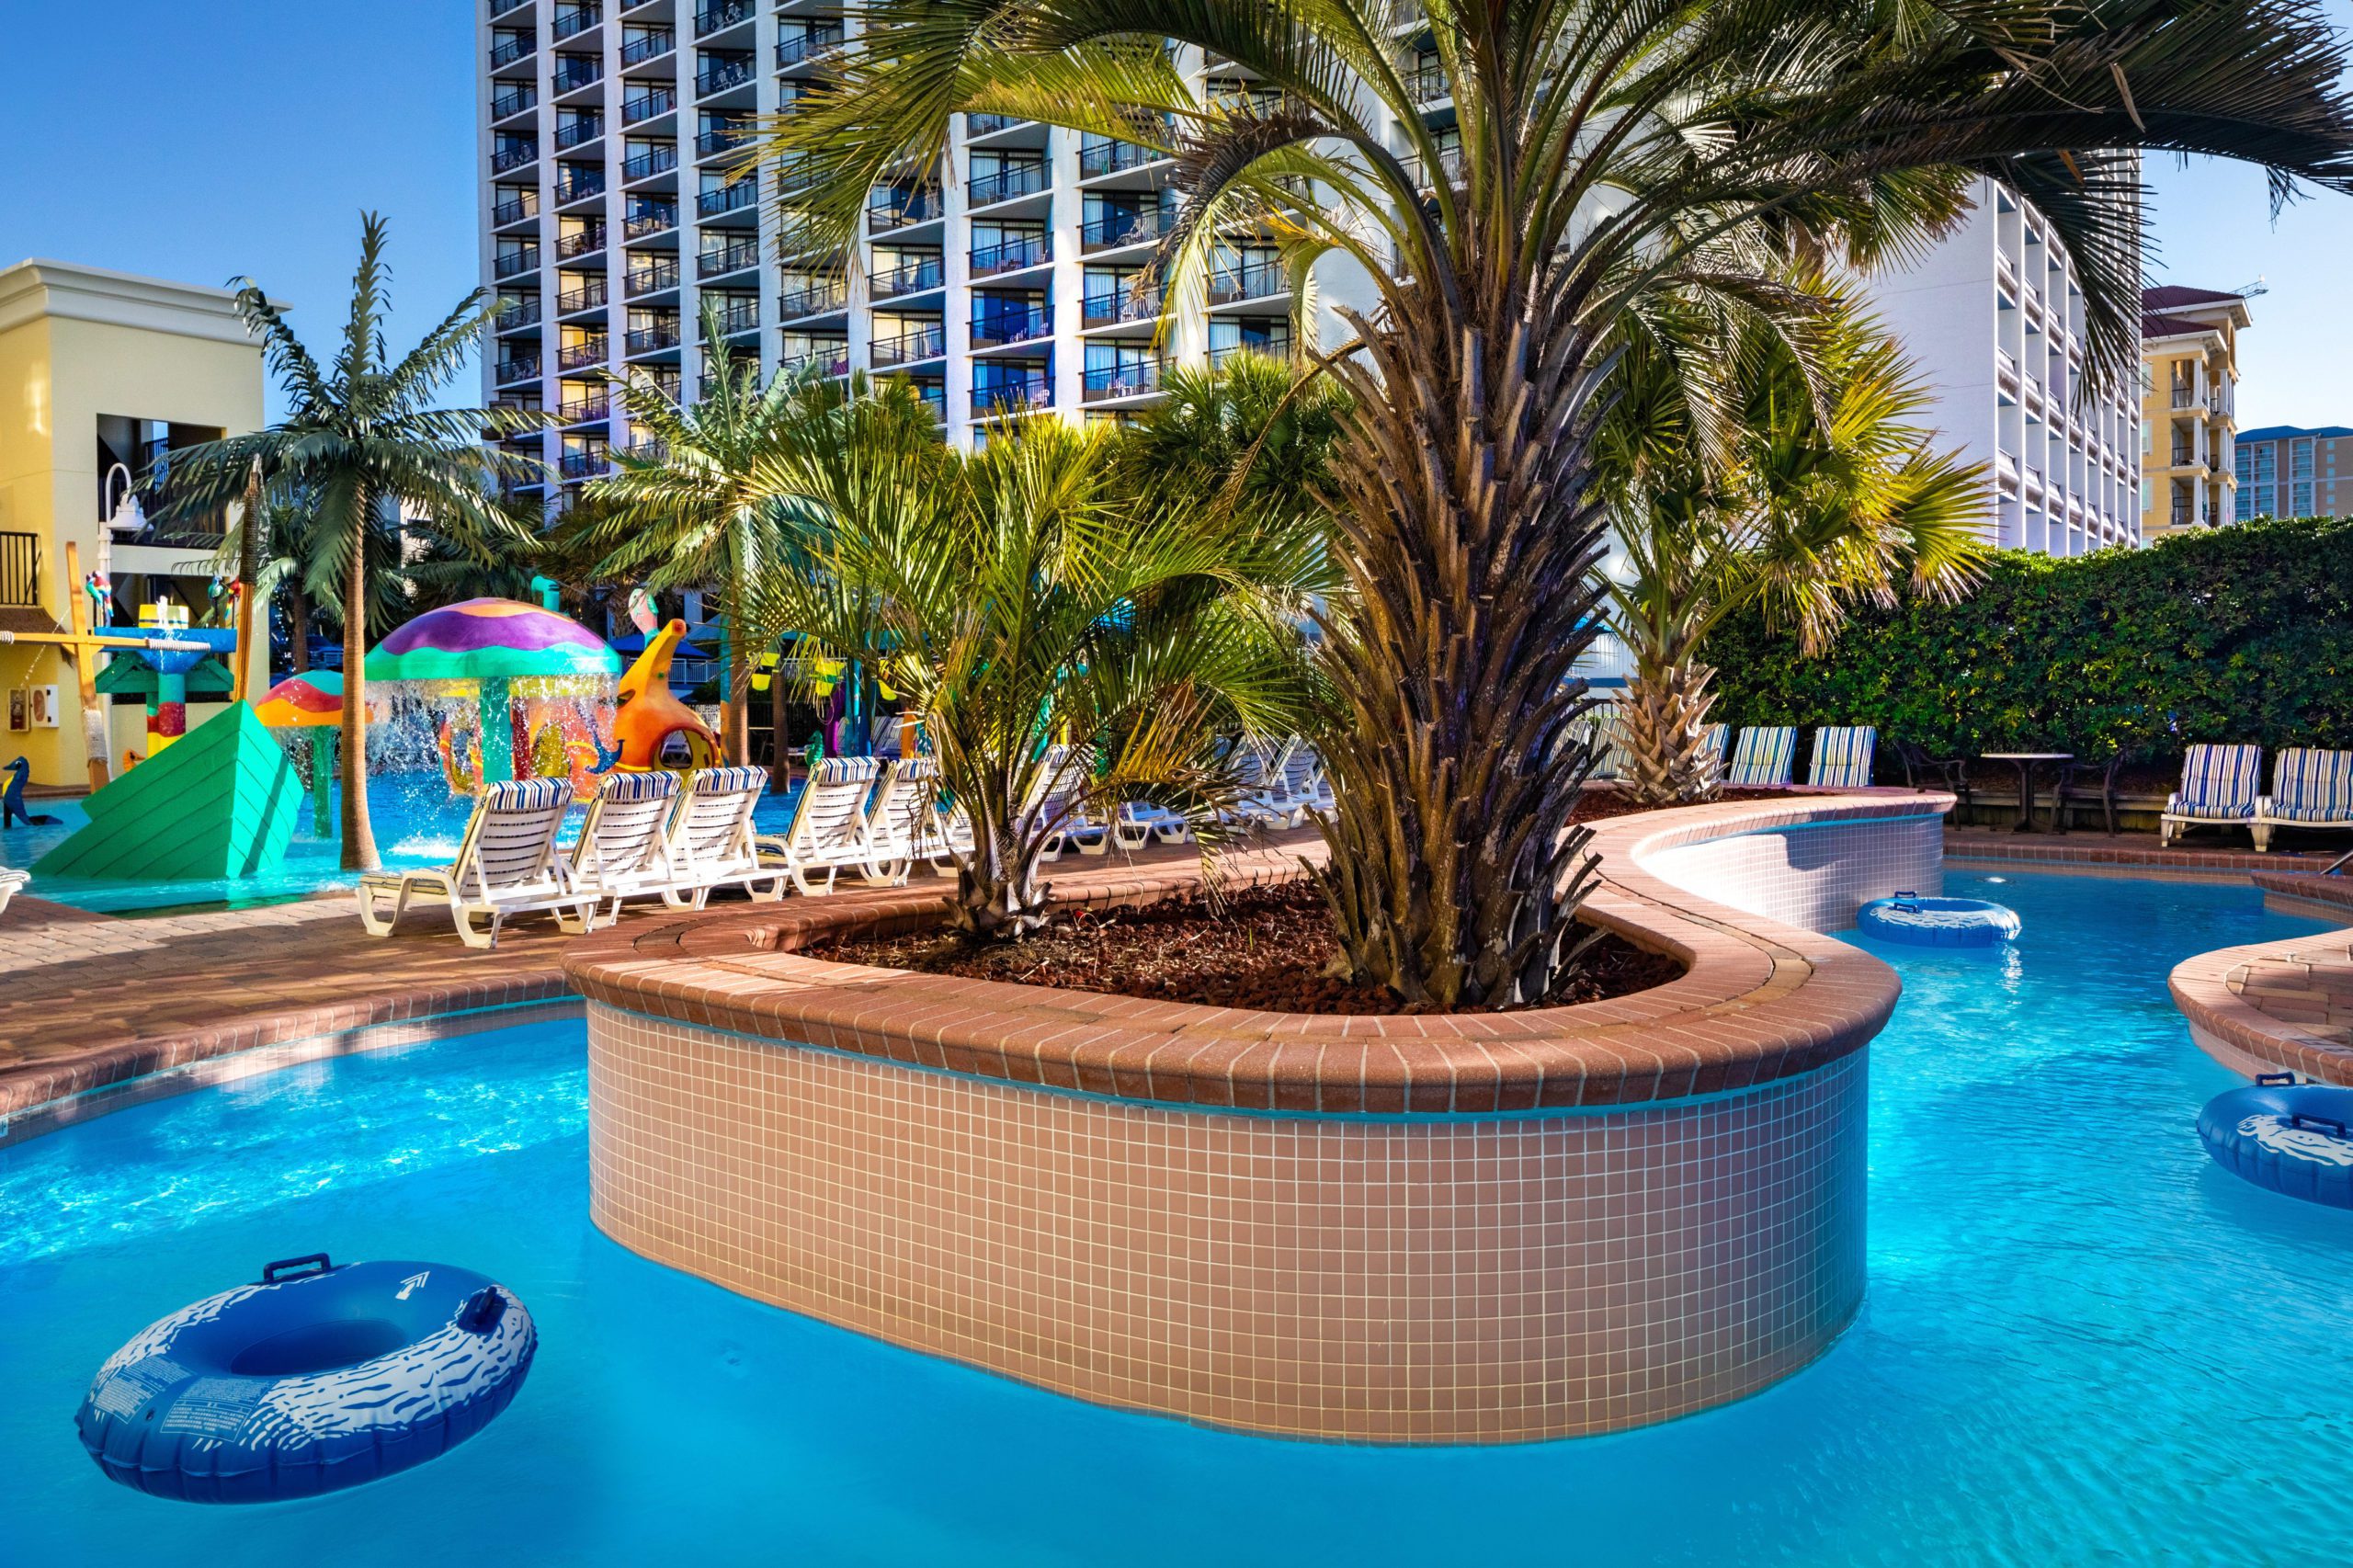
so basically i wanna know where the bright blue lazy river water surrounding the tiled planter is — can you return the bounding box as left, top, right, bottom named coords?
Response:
left=0, top=873, right=2353, bottom=1568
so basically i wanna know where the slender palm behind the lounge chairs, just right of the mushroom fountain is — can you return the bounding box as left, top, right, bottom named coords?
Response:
left=579, top=303, right=884, bottom=763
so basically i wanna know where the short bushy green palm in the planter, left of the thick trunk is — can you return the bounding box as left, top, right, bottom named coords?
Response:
left=769, top=419, right=1324, bottom=939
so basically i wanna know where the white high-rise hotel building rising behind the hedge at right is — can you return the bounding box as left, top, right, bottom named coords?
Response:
left=1869, top=184, right=2142, bottom=556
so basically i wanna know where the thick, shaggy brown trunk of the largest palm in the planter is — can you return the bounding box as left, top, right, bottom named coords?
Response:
left=1318, top=288, right=1605, bottom=1007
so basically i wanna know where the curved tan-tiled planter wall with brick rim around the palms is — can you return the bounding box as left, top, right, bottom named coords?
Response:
left=567, top=793, right=1944, bottom=1443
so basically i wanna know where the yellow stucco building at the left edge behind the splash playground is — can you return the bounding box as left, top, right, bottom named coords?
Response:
left=0, top=261, right=268, bottom=787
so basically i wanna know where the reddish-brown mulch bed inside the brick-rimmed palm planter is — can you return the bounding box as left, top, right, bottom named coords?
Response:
left=807, top=883, right=1682, bottom=1012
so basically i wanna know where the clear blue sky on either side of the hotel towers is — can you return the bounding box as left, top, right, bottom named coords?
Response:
left=0, top=0, right=2353, bottom=426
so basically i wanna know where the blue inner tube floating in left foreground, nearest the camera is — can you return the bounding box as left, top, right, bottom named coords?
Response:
left=75, top=1253, right=539, bottom=1502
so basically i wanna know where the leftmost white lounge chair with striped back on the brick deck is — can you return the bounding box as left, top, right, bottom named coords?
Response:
left=358, top=779, right=597, bottom=947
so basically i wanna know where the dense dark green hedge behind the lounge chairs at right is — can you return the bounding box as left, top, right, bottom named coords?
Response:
left=1706, top=518, right=2353, bottom=758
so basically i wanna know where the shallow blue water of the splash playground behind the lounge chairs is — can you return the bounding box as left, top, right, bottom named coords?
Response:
left=0, top=775, right=793, bottom=914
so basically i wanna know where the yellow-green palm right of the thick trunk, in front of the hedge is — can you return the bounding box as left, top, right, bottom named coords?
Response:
left=1597, top=276, right=1991, bottom=805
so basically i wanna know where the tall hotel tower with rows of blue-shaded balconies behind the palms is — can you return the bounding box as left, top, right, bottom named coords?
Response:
left=478, top=0, right=1392, bottom=501
